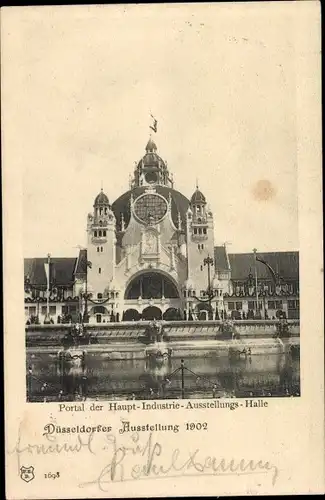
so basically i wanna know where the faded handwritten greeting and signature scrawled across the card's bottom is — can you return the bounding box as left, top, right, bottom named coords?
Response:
left=11, top=427, right=279, bottom=492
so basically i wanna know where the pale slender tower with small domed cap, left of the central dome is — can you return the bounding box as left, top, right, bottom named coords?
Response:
left=87, top=190, right=115, bottom=298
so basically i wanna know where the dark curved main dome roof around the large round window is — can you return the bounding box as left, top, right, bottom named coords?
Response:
left=112, top=186, right=190, bottom=227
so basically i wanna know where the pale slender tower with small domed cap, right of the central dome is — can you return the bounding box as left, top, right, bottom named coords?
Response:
left=186, top=186, right=214, bottom=296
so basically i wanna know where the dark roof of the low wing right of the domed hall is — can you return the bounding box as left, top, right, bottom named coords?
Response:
left=228, top=252, right=299, bottom=280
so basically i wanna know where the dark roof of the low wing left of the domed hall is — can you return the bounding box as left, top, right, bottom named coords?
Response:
left=24, top=257, right=77, bottom=286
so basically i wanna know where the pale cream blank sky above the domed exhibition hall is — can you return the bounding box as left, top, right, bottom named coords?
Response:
left=5, top=2, right=299, bottom=257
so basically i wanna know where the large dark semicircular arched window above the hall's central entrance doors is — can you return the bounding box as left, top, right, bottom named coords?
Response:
left=124, top=271, right=179, bottom=300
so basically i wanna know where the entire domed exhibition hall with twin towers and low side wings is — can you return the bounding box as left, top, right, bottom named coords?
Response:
left=25, top=138, right=299, bottom=323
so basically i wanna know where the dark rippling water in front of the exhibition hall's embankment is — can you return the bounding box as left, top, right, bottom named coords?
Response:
left=27, top=349, right=300, bottom=401
